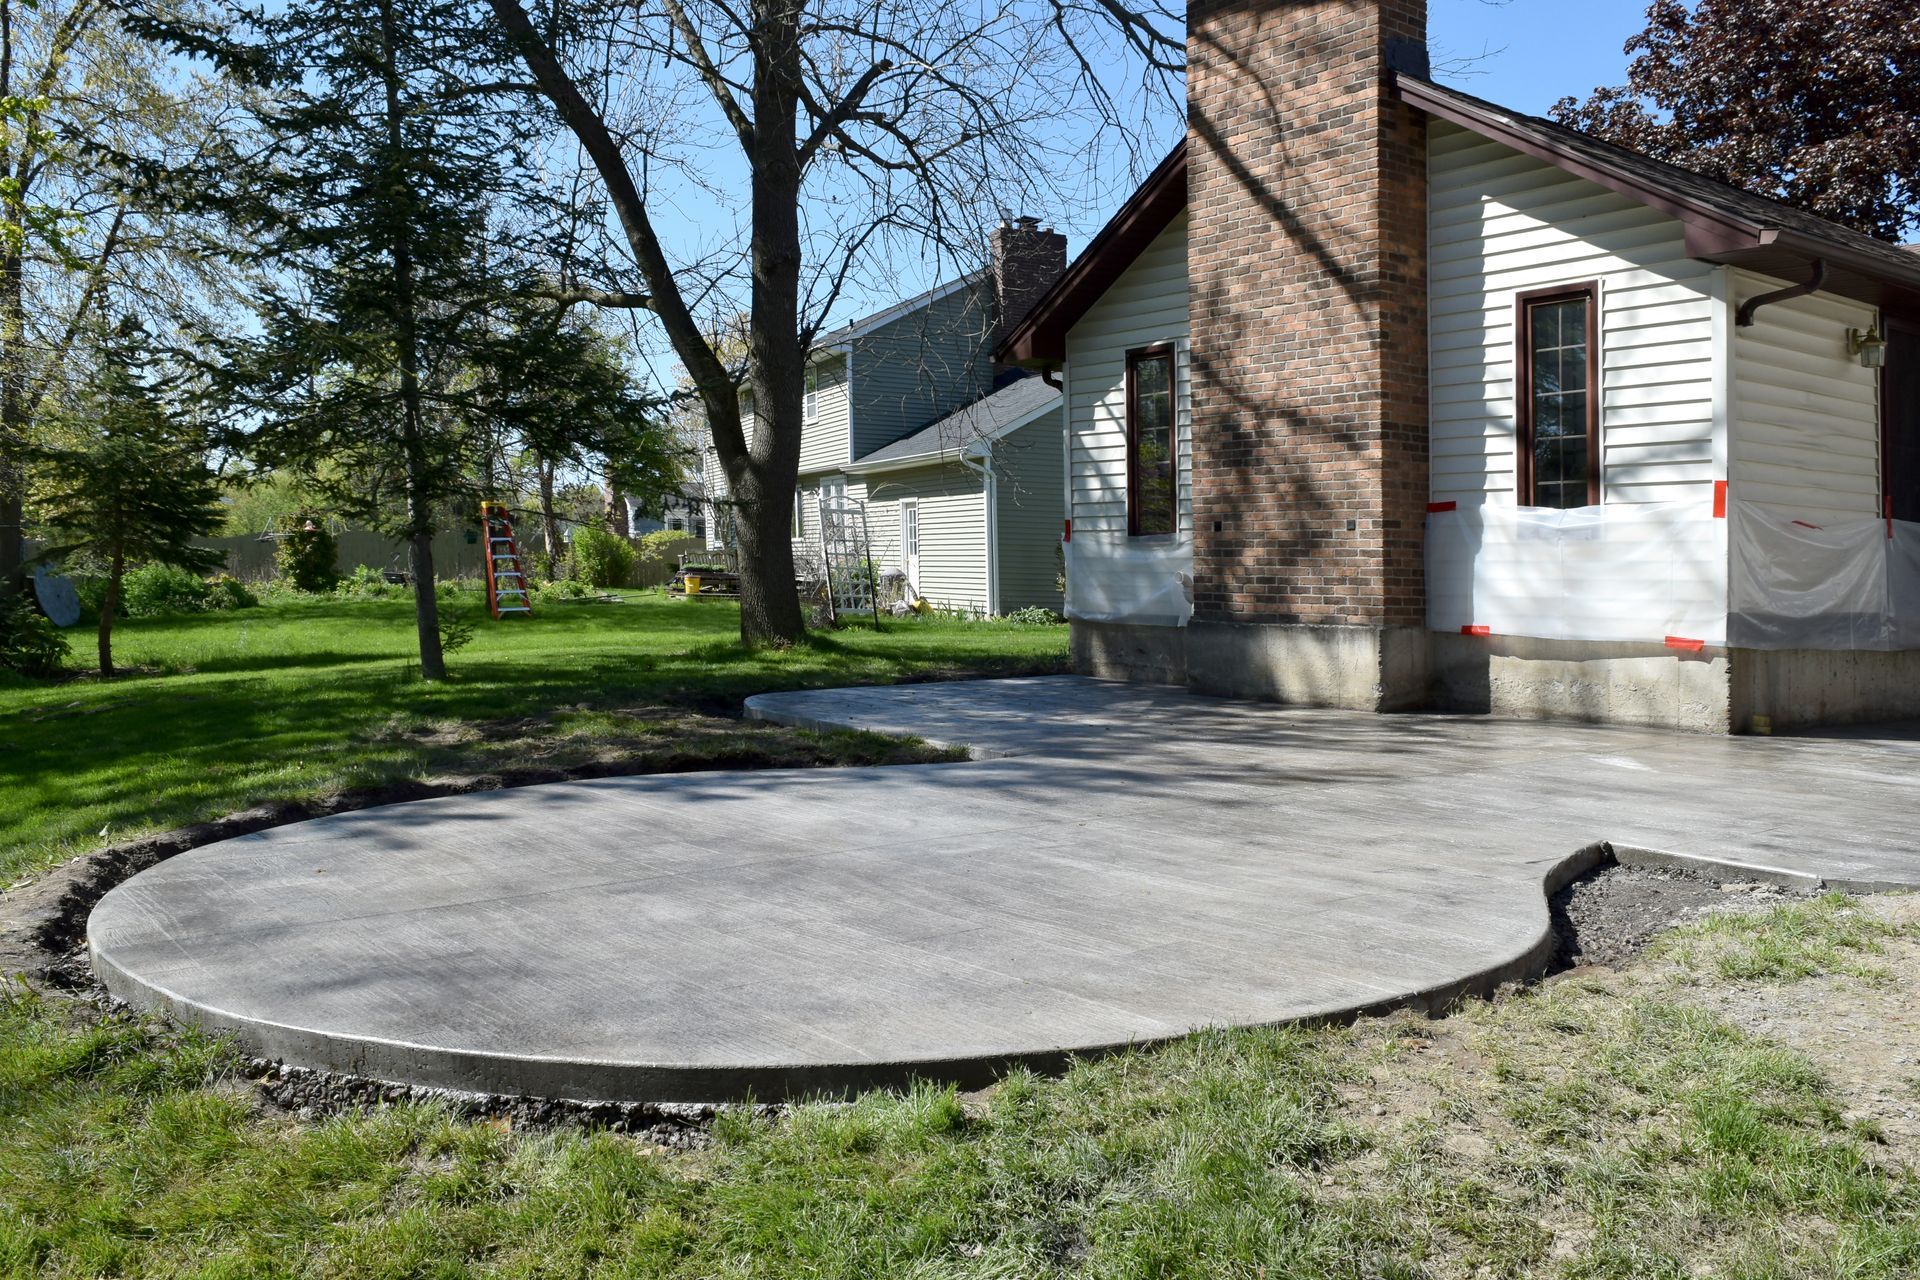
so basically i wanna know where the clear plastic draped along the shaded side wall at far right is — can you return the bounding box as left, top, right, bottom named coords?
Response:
left=1726, top=503, right=1920, bottom=649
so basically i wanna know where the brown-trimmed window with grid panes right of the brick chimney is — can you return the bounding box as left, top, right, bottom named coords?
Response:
left=1515, top=282, right=1599, bottom=509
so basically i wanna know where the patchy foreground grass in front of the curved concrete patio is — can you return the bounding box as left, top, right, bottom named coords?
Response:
left=0, top=898, right=1920, bottom=1280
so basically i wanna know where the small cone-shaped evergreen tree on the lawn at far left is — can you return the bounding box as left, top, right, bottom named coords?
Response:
left=35, top=322, right=225, bottom=676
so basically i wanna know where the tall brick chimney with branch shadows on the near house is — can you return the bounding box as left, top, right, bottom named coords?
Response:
left=1187, top=0, right=1427, bottom=626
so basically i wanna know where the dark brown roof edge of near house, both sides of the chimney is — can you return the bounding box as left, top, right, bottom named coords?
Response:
left=995, top=73, right=1920, bottom=368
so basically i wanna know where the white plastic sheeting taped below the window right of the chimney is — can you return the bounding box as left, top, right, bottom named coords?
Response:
left=1427, top=503, right=1726, bottom=645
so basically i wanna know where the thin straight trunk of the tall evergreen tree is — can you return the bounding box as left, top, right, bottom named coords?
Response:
left=380, top=0, right=447, bottom=679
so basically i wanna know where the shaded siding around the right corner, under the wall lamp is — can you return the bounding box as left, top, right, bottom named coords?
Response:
left=1730, top=273, right=1882, bottom=520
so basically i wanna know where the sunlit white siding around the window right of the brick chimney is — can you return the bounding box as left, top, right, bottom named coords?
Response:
left=1428, top=121, right=1718, bottom=503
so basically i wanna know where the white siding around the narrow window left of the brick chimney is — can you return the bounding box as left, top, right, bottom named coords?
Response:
left=1068, top=213, right=1192, bottom=533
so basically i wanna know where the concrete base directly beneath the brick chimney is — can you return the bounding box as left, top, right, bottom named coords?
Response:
left=1187, top=618, right=1428, bottom=712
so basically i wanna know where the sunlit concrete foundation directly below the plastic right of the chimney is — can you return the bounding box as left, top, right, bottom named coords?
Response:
left=1428, top=631, right=1734, bottom=733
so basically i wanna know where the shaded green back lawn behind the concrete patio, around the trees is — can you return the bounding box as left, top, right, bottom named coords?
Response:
left=0, top=593, right=1068, bottom=887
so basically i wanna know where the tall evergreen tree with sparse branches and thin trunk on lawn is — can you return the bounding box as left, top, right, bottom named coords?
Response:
left=159, top=0, right=647, bottom=679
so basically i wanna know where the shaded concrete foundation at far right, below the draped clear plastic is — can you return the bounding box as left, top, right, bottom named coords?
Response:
left=1732, top=649, right=1920, bottom=733
